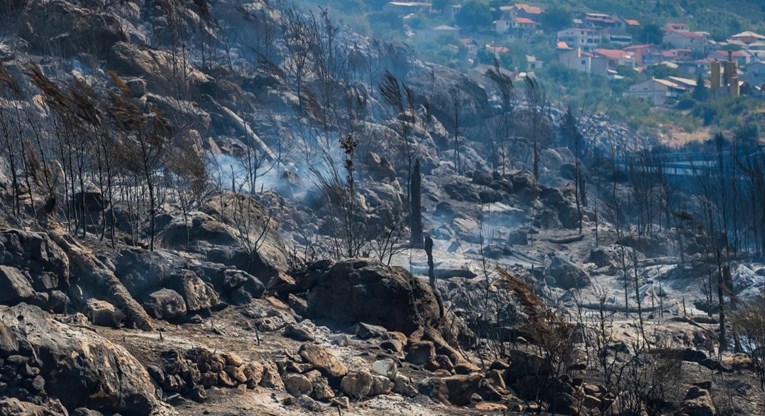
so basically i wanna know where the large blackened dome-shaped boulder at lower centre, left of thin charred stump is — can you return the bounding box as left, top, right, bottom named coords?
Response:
left=300, top=260, right=440, bottom=334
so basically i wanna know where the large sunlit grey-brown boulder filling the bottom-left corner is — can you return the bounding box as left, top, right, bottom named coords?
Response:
left=0, top=304, right=172, bottom=415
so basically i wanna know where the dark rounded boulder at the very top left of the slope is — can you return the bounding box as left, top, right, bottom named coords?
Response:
left=19, top=0, right=128, bottom=56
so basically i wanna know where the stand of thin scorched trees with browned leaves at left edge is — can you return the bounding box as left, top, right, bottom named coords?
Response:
left=0, top=64, right=209, bottom=249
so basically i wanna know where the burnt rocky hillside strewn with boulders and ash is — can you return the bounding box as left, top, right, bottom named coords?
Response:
left=0, top=0, right=765, bottom=416
